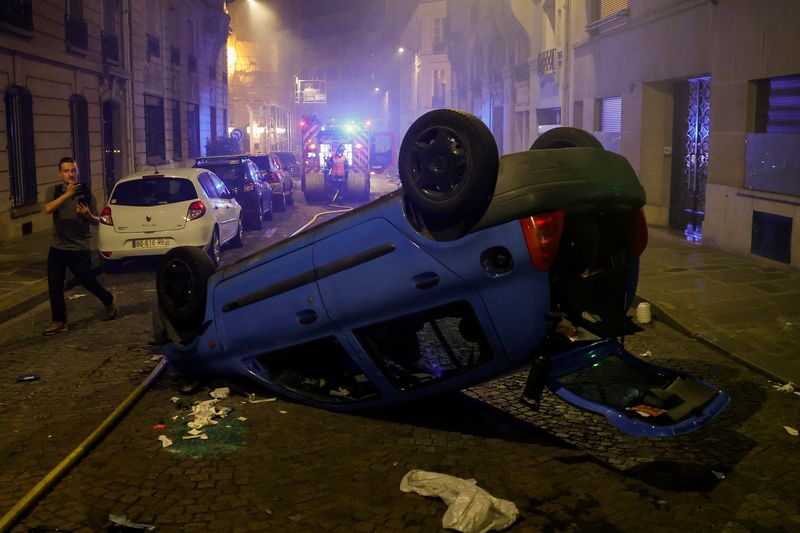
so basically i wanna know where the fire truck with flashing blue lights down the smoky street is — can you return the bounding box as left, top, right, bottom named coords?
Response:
left=300, top=116, right=395, bottom=202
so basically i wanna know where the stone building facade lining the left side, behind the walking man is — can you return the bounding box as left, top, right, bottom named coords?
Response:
left=0, top=0, right=230, bottom=240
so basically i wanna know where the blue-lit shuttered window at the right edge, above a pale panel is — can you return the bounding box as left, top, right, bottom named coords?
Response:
left=756, top=76, right=800, bottom=133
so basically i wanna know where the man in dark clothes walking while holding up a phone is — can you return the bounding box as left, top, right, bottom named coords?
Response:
left=42, top=157, right=119, bottom=335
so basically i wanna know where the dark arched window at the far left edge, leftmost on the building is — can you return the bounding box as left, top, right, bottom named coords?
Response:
left=5, top=86, right=38, bottom=207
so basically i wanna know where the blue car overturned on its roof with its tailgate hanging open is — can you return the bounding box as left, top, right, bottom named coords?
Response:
left=154, top=109, right=729, bottom=436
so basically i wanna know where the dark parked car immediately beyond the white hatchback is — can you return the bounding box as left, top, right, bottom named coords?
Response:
left=194, top=155, right=272, bottom=230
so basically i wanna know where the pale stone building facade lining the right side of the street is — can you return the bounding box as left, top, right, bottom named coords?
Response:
left=447, top=0, right=800, bottom=268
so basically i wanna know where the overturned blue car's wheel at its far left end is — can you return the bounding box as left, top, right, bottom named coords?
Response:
left=156, top=246, right=214, bottom=340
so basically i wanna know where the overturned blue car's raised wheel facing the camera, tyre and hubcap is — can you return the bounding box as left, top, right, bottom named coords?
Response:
left=398, top=109, right=500, bottom=233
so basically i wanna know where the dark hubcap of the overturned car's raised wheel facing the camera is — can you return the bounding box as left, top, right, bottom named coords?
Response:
left=408, top=127, right=469, bottom=201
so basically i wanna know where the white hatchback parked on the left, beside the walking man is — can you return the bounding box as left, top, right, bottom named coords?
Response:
left=98, top=168, right=244, bottom=266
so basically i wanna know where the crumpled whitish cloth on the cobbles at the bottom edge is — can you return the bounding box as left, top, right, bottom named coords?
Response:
left=400, top=470, right=519, bottom=533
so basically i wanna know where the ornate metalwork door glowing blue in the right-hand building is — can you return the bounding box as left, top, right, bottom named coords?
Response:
left=669, top=77, right=711, bottom=242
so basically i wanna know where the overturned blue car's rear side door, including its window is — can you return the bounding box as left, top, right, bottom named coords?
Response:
left=314, top=218, right=504, bottom=403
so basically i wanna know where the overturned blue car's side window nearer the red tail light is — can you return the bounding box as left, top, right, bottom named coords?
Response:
left=354, top=302, right=491, bottom=390
